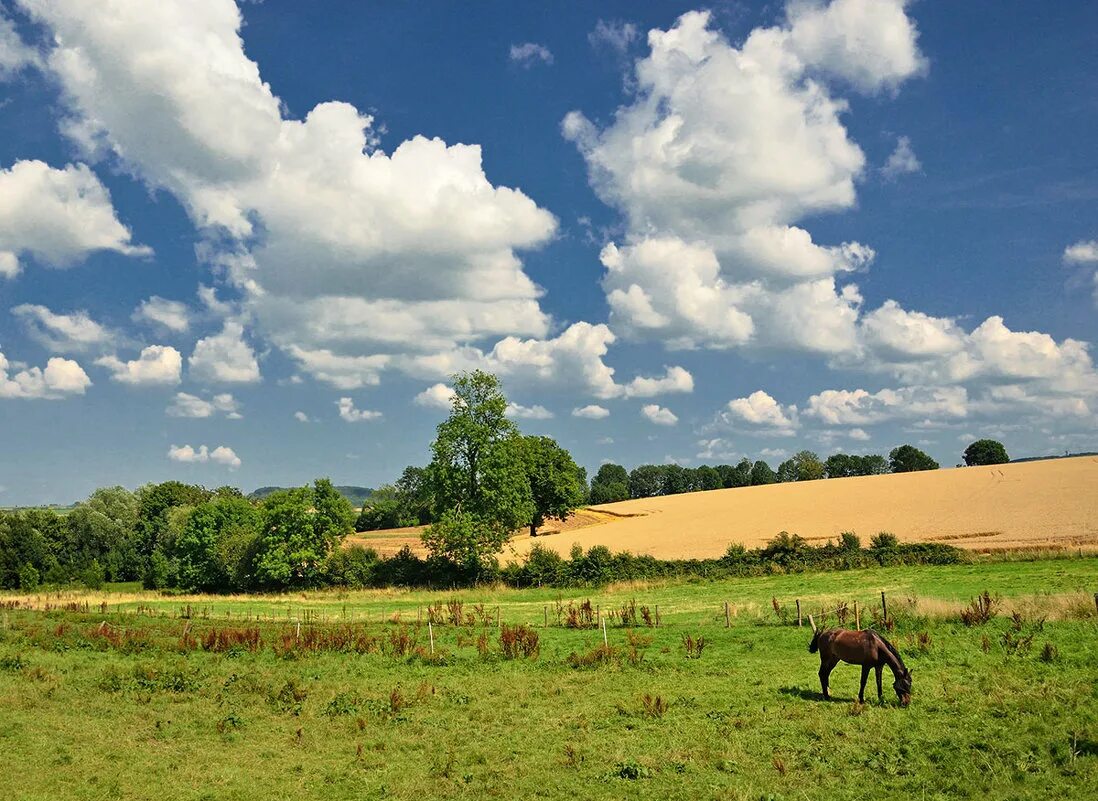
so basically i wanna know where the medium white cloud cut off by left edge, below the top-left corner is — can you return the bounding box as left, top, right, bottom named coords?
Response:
left=0, top=161, right=152, bottom=278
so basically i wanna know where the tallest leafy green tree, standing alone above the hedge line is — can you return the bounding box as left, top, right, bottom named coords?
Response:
left=424, top=370, right=535, bottom=568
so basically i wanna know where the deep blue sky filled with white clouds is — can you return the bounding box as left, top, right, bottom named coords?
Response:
left=0, top=0, right=1098, bottom=506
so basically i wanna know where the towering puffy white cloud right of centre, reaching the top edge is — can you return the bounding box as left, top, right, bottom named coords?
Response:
left=562, top=0, right=922, bottom=353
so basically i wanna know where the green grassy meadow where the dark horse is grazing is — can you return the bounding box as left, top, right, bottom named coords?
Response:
left=0, top=559, right=1098, bottom=801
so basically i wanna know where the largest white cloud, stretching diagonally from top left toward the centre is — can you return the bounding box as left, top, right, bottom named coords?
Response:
left=20, top=0, right=557, bottom=380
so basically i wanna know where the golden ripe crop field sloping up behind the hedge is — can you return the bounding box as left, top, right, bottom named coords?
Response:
left=502, top=456, right=1098, bottom=559
